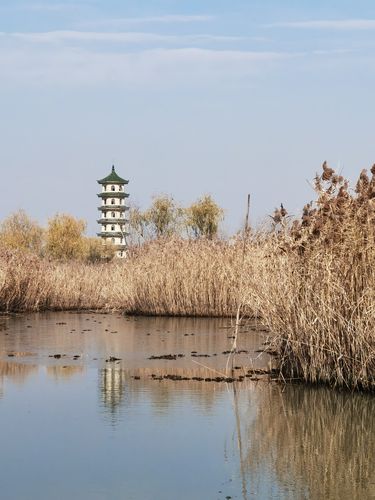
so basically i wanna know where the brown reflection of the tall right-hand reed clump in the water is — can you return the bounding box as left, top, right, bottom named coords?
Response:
left=242, top=386, right=375, bottom=500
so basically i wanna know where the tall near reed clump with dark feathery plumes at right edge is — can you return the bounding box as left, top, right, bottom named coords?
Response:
left=249, top=164, right=375, bottom=390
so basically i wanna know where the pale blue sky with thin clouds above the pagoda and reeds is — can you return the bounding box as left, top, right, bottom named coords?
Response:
left=0, top=0, right=375, bottom=234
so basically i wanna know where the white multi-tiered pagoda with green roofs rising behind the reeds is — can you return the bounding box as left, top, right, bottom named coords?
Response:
left=97, top=166, right=129, bottom=258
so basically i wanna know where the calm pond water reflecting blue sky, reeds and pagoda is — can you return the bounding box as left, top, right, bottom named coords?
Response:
left=0, top=313, right=375, bottom=500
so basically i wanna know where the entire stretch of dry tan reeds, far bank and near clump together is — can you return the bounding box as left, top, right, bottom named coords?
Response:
left=0, top=164, right=375, bottom=390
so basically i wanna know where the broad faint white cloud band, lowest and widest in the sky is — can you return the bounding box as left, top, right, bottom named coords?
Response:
left=0, top=45, right=290, bottom=86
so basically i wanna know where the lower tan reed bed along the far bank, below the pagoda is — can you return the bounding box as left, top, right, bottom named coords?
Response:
left=0, top=240, right=254, bottom=316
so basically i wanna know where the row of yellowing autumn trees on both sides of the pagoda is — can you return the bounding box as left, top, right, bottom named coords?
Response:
left=0, top=195, right=224, bottom=262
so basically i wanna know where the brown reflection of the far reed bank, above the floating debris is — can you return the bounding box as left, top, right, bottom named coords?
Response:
left=0, top=312, right=268, bottom=371
